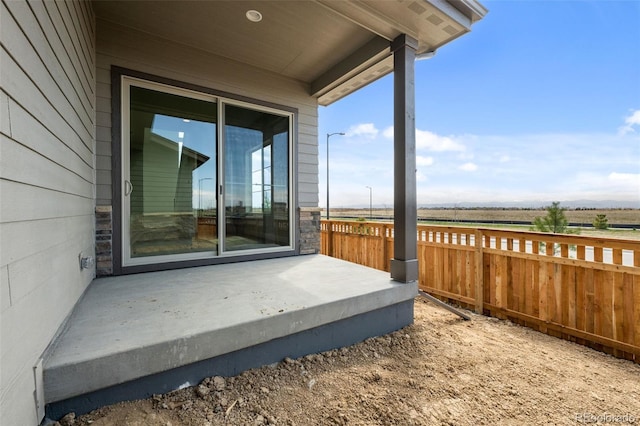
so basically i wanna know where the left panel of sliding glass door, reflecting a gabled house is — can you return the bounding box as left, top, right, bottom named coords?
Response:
left=123, top=80, right=218, bottom=264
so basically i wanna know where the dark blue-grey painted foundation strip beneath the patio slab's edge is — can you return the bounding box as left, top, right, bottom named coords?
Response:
left=46, top=298, right=414, bottom=420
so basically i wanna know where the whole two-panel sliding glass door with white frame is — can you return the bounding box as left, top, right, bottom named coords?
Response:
left=122, top=77, right=292, bottom=266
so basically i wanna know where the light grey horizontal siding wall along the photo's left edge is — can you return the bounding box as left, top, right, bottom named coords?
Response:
left=0, top=0, right=95, bottom=425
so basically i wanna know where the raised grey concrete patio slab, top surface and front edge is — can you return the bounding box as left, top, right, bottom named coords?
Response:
left=44, top=255, right=417, bottom=410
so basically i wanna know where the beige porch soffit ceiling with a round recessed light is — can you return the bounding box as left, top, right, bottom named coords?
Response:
left=93, top=0, right=486, bottom=105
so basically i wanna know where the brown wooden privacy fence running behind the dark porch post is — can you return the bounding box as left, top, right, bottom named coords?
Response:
left=321, top=220, right=640, bottom=364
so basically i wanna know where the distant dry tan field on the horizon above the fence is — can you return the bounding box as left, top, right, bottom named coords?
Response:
left=331, top=209, right=640, bottom=225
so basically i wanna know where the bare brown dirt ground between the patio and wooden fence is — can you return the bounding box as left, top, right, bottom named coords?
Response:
left=60, top=298, right=640, bottom=426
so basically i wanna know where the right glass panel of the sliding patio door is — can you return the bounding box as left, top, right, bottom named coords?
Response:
left=223, top=105, right=291, bottom=251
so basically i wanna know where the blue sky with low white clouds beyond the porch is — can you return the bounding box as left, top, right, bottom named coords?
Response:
left=319, top=0, right=640, bottom=208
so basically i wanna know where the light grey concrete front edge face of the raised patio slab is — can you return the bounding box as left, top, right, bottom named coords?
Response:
left=44, top=282, right=417, bottom=403
